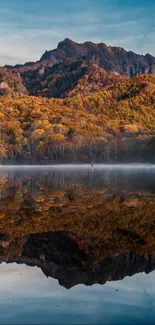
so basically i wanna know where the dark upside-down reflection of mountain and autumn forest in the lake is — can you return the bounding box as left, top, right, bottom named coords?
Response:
left=0, top=167, right=155, bottom=289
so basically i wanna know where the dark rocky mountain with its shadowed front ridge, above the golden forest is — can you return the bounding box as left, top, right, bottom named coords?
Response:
left=5, top=38, right=155, bottom=98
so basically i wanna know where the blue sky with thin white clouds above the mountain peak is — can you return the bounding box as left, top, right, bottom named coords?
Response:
left=0, top=0, right=155, bottom=65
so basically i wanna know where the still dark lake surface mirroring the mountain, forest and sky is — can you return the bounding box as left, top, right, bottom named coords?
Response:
left=0, top=166, right=155, bottom=324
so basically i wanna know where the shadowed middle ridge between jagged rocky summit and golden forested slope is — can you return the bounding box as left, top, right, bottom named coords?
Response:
left=17, top=59, right=123, bottom=98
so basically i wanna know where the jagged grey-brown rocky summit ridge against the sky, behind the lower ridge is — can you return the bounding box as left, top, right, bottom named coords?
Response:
left=40, top=38, right=155, bottom=77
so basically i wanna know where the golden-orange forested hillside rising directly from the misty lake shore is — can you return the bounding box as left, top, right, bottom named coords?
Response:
left=0, top=75, right=155, bottom=163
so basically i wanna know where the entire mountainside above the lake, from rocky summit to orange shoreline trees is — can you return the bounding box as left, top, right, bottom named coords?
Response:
left=0, top=39, right=155, bottom=164
